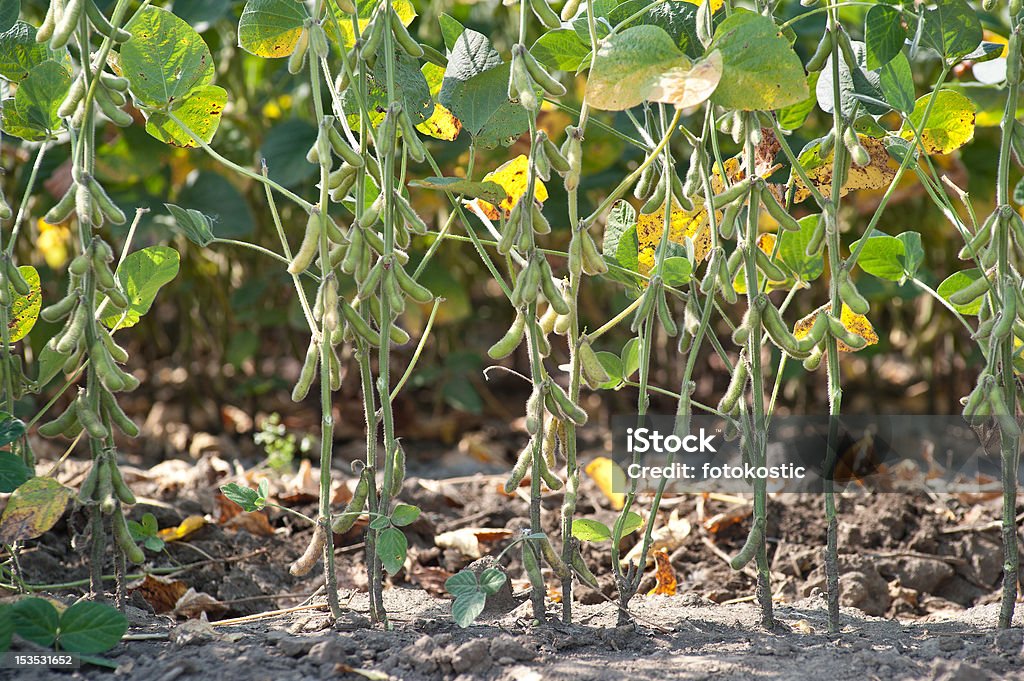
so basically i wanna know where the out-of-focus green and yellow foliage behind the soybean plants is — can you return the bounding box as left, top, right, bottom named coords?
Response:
left=0, top=0, right=1016, bottom=446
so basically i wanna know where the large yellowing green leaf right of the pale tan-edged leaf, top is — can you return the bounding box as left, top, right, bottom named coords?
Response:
left=709, top=9, right=808, bottom=111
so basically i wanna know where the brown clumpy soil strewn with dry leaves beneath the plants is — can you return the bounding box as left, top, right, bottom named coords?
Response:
left=0, top=421, right=1024, bottom=681
